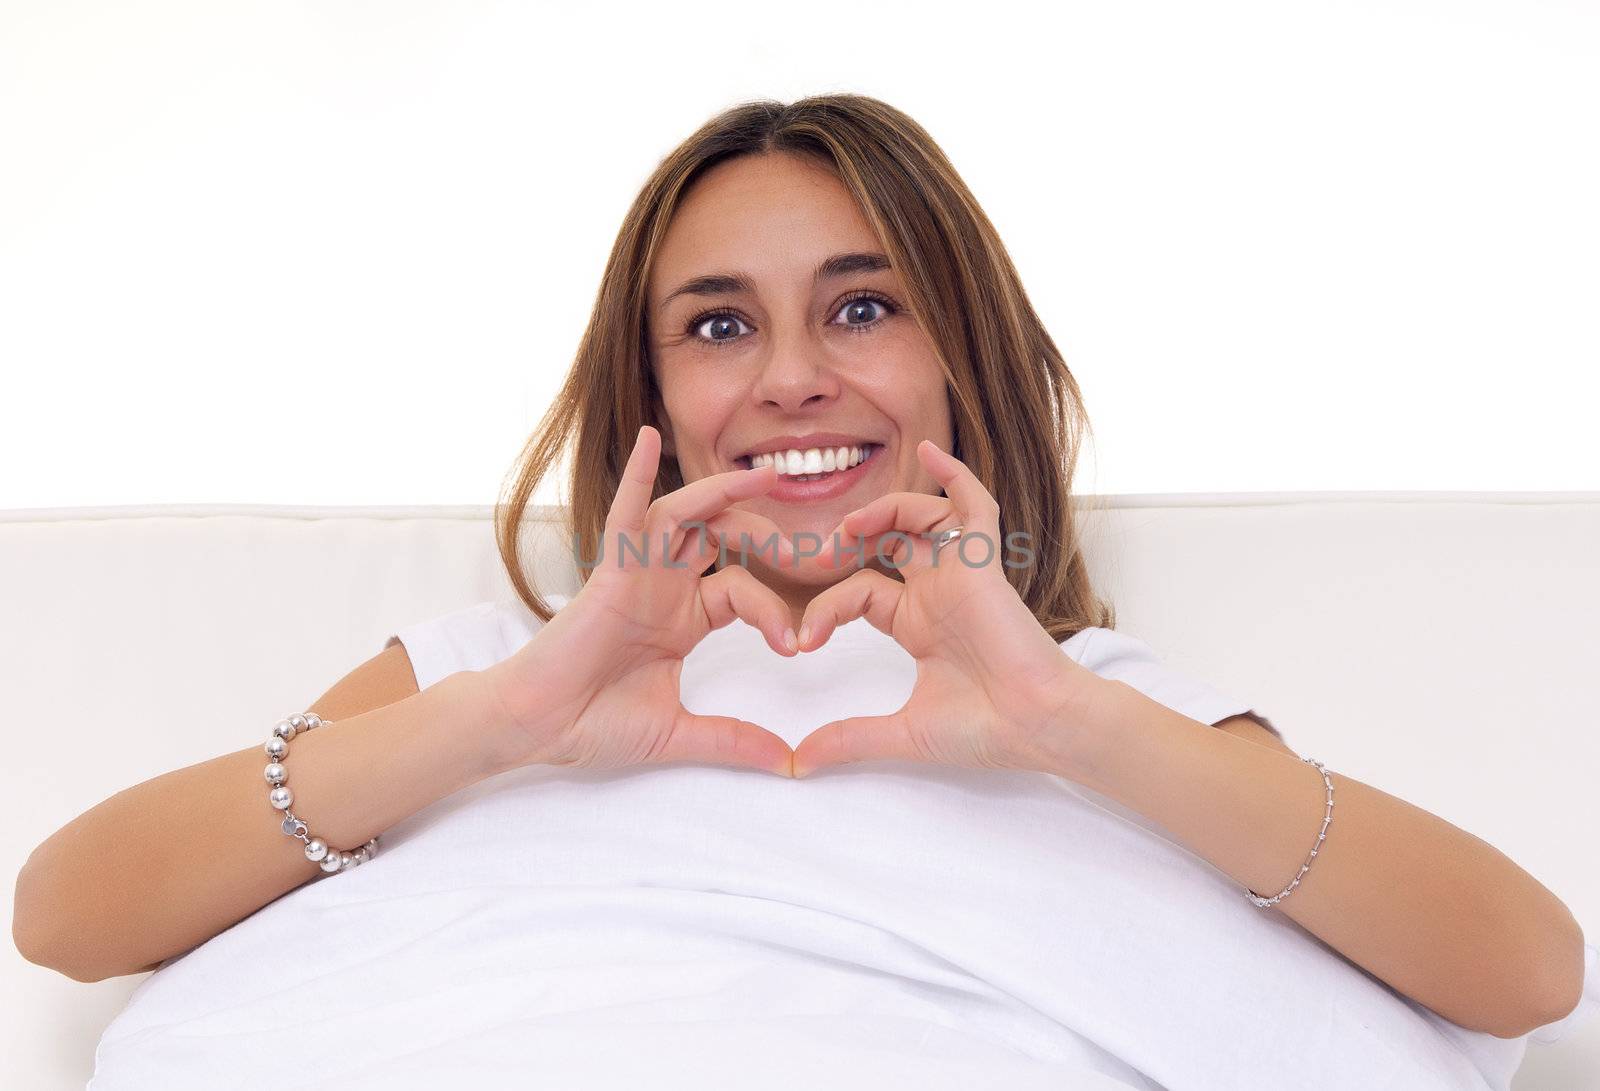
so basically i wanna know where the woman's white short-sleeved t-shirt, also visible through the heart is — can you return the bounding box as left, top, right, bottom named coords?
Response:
left=90, top=598, right=1523, bottom=1091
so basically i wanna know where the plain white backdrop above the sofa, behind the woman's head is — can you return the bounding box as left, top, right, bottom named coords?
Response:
left=0, top=0, right=1600, bottom=507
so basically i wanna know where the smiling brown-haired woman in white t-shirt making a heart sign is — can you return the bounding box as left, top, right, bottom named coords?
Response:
left=16, top=94, right=1584, bottom=1089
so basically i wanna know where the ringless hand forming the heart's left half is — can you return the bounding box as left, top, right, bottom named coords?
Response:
left=483, top=426, right=798, bottom=776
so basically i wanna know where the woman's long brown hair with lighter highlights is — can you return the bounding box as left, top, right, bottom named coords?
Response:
left=494, top=94, right=1115, bottom=641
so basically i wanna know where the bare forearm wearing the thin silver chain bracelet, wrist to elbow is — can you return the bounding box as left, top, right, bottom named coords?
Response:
left=1046, top=680, right=1584, bottom=1038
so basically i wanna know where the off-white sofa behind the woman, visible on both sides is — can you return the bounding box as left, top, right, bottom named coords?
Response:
left=0, top=493, right=1600, bottom=1091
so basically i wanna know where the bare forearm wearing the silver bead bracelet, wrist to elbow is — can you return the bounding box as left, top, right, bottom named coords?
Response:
left=13, top=670, right=499, bottom=981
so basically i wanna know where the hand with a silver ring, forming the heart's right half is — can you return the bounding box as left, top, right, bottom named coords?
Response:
left=794, top=440, right=1099, bottom=777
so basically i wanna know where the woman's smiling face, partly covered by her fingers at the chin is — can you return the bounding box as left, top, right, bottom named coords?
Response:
left=648, top=154, right=952, bottom=584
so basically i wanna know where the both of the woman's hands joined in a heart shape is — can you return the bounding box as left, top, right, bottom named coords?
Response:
left=483, top=426, right=1098, bottom=777
